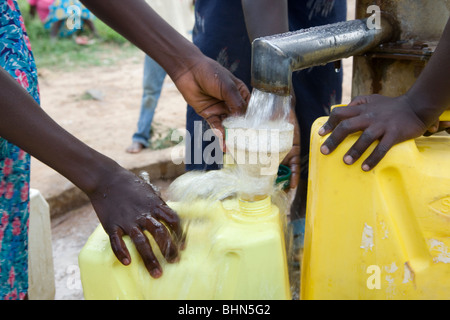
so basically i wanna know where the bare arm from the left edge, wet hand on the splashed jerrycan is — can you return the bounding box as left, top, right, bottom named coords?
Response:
left=0, top=68, right=182, bottom=277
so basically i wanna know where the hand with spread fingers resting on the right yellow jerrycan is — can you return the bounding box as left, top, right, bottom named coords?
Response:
left=319, top=95, right=427, bottom=171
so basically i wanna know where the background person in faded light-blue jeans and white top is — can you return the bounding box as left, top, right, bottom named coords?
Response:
left=126, top=0, right=194, bottom=153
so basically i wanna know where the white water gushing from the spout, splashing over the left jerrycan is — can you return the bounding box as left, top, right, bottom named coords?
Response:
left=169, top=89, right=294, bottom=202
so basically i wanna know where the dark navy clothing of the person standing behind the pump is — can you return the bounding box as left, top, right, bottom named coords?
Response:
left=186, top=0, right=347, bottom=179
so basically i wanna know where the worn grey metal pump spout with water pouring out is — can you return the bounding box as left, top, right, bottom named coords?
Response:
left=252, top=19, right=393, bottom=95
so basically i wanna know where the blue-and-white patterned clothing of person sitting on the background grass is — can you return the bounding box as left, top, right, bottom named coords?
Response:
left=44, top=0, right=95, bottom=37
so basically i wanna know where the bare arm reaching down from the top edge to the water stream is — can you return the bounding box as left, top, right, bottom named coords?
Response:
left=82, top=0, right=250, bottom=136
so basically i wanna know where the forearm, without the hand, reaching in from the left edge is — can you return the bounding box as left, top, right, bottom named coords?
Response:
left=0, top=68, right=116, bottom=193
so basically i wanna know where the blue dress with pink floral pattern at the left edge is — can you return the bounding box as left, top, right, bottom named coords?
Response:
left=0, top=0, right=40, bottom=300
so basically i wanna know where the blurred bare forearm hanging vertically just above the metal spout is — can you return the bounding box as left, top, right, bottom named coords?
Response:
left=242, top=0, right=289, bottom=42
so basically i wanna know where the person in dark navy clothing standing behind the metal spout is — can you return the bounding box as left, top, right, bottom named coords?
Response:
left=186, top=0, right=347, bottom=262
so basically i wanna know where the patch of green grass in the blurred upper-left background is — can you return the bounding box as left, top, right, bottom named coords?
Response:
left=17, top=0, right=138, bottom=70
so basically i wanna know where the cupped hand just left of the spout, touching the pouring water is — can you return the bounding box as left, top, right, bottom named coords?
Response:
left=174, top=57, right=250, bottom=141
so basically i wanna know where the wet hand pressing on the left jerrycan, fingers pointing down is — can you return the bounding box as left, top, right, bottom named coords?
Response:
left=84, top=168, right=182, bottom=278
